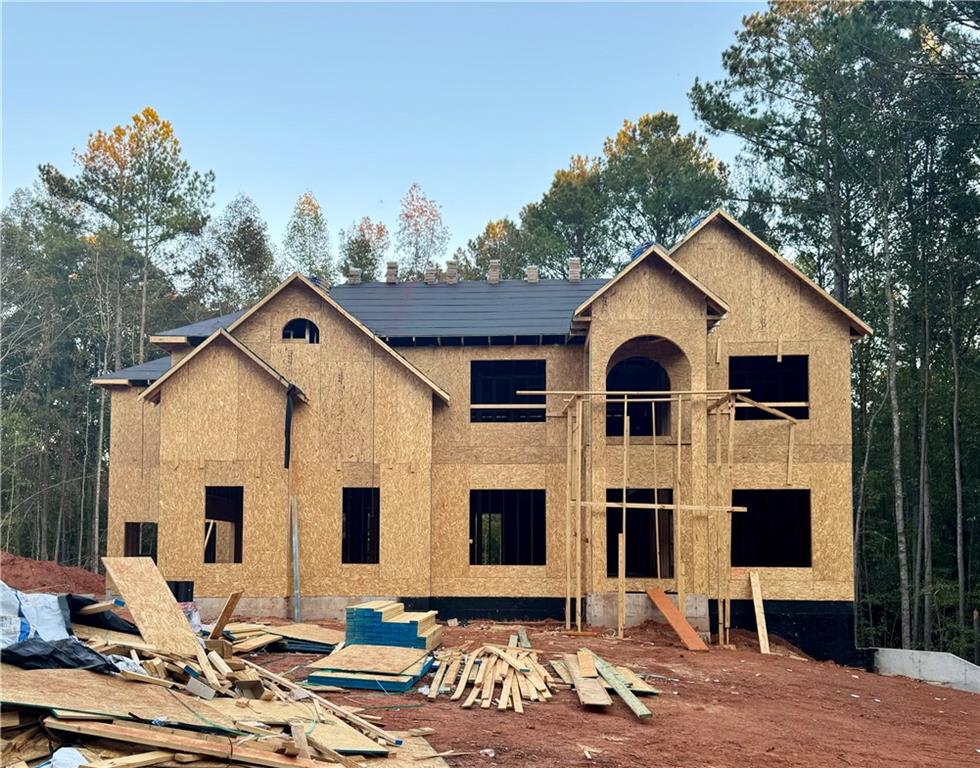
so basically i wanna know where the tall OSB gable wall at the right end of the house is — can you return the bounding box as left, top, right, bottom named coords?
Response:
left=672, top=219, right=853, bottom=600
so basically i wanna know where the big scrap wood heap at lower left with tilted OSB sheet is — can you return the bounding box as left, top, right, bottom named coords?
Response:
left=0, top=558, right=444, bottom=768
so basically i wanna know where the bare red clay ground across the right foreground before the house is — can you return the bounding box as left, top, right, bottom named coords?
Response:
left=255, top=622, right=980, bottom=768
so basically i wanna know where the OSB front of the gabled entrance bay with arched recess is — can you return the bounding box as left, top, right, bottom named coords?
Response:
left=583, top=259, right=708, bottom=593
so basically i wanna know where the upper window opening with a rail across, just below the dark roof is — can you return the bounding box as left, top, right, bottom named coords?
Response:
left=470, top=360, right=546, bottom=422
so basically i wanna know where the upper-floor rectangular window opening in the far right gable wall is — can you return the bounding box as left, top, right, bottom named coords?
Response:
left=728, top=355, right=810, bottom=421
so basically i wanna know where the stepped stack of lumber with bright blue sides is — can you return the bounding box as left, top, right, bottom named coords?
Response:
left=345, top=600, right=443, bottom=651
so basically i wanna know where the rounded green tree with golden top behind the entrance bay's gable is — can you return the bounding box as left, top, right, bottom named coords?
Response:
left=602, top=112, right=729, bottom=253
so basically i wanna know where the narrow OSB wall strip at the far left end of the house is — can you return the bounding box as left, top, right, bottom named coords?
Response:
left=106, top=387, right=160, bottom=557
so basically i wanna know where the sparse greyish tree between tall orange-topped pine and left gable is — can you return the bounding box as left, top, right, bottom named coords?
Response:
left=187, top=195, right=279, bottom=314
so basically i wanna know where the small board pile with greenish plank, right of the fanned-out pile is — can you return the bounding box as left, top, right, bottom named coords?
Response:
left=551, top=648, right=660, bottom=718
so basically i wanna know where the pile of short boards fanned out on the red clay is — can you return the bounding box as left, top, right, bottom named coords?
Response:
left=428, top=644, right=556, bottom=714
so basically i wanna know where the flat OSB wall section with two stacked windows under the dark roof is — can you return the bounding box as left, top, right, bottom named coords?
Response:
left=402, top=345, right=583, bottom=597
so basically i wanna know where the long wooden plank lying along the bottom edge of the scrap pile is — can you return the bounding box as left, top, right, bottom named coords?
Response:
left=44, top=717, right=320, bottom=768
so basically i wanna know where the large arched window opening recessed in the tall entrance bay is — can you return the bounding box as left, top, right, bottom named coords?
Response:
left=606, top=356, right=670, bottom=437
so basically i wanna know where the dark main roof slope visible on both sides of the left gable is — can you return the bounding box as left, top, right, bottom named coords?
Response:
left=154, top=280, right=606, bottom=338
